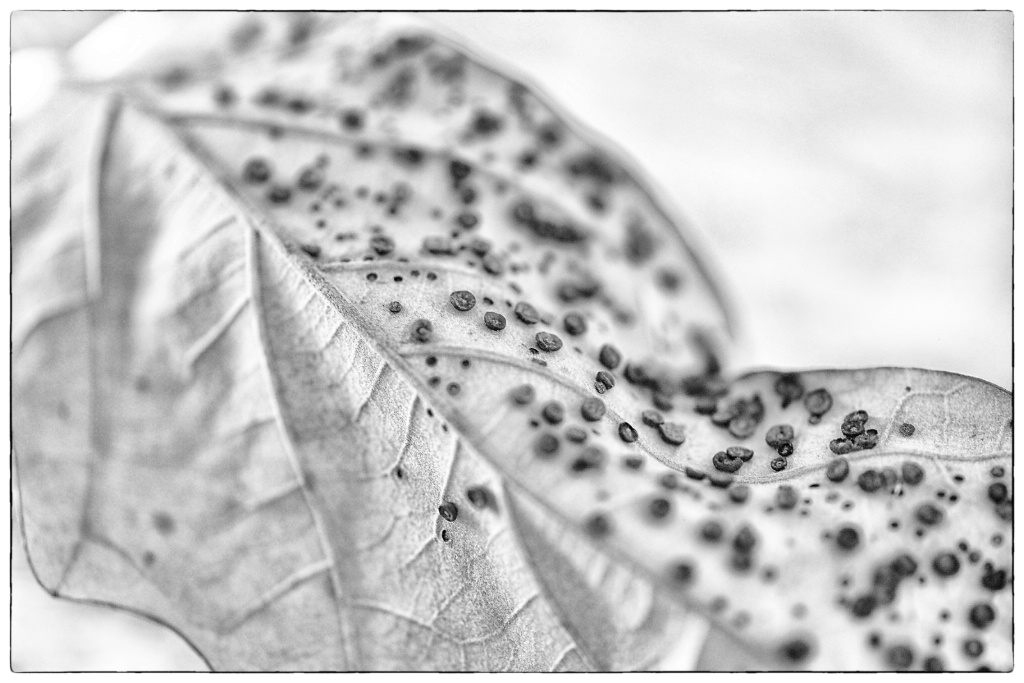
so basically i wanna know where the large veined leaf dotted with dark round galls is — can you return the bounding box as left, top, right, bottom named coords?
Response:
left=13, top=10, right=1012, bottom=670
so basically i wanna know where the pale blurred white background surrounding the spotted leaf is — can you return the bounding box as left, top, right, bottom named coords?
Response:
left=11, top=11, right=1013, bottom=671
